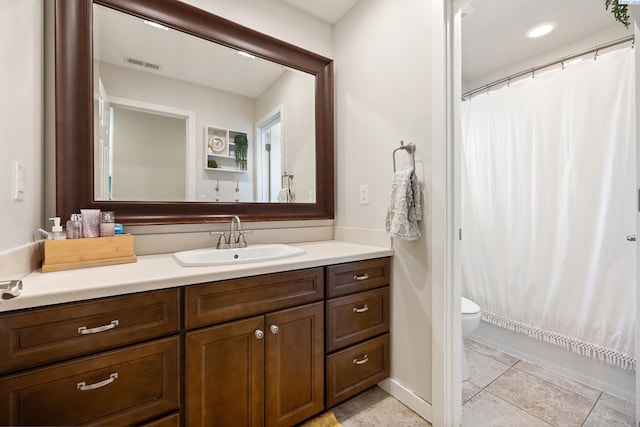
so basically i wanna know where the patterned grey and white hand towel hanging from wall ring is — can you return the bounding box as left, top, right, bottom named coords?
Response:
left=385, top=170, right=422, bottom=240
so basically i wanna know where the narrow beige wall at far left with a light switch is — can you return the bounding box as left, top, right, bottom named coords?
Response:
left=0, top=0, right=46, bottom=279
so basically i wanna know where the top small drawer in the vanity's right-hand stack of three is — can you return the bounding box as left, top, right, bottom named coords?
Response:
left=327, top=258, right=389, bottom=298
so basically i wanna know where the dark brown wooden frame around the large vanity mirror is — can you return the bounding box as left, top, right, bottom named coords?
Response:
left=54, top=0, right=334, bottom=225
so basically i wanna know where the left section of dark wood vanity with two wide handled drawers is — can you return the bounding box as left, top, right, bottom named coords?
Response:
left=0, top=289, right=181, bottom=426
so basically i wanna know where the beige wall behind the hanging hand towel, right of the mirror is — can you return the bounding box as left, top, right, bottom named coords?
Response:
left=334, top=0, right=432, bottom=402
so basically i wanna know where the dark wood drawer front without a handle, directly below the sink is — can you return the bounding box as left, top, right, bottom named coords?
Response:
left=185, top=267, right=324, bottom=329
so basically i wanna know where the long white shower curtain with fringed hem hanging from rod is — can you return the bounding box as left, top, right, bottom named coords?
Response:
left=462, top=48, right=636, bottom=369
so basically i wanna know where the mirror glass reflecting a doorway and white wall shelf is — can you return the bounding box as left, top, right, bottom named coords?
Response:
left=93, top=4, right=316, bottom=203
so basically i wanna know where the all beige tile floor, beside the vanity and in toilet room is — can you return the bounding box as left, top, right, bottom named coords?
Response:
left=333, top=339, right=635, bottom=427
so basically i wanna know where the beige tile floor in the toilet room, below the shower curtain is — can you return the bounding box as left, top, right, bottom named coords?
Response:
left=462, top=339, right=636, bottom=427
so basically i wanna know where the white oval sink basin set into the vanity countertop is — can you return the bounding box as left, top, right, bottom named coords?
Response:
left=173, top=244, right=304, bottom=267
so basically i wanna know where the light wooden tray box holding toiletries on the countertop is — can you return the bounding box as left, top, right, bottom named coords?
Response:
left=42, top=234, right=138, bottom=273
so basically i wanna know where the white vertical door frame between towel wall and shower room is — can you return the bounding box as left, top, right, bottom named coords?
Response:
left=431, top=0, right=468, bottom=427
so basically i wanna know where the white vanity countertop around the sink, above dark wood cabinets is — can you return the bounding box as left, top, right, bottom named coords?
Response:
left=0, top=240, right=393, bottom=312
